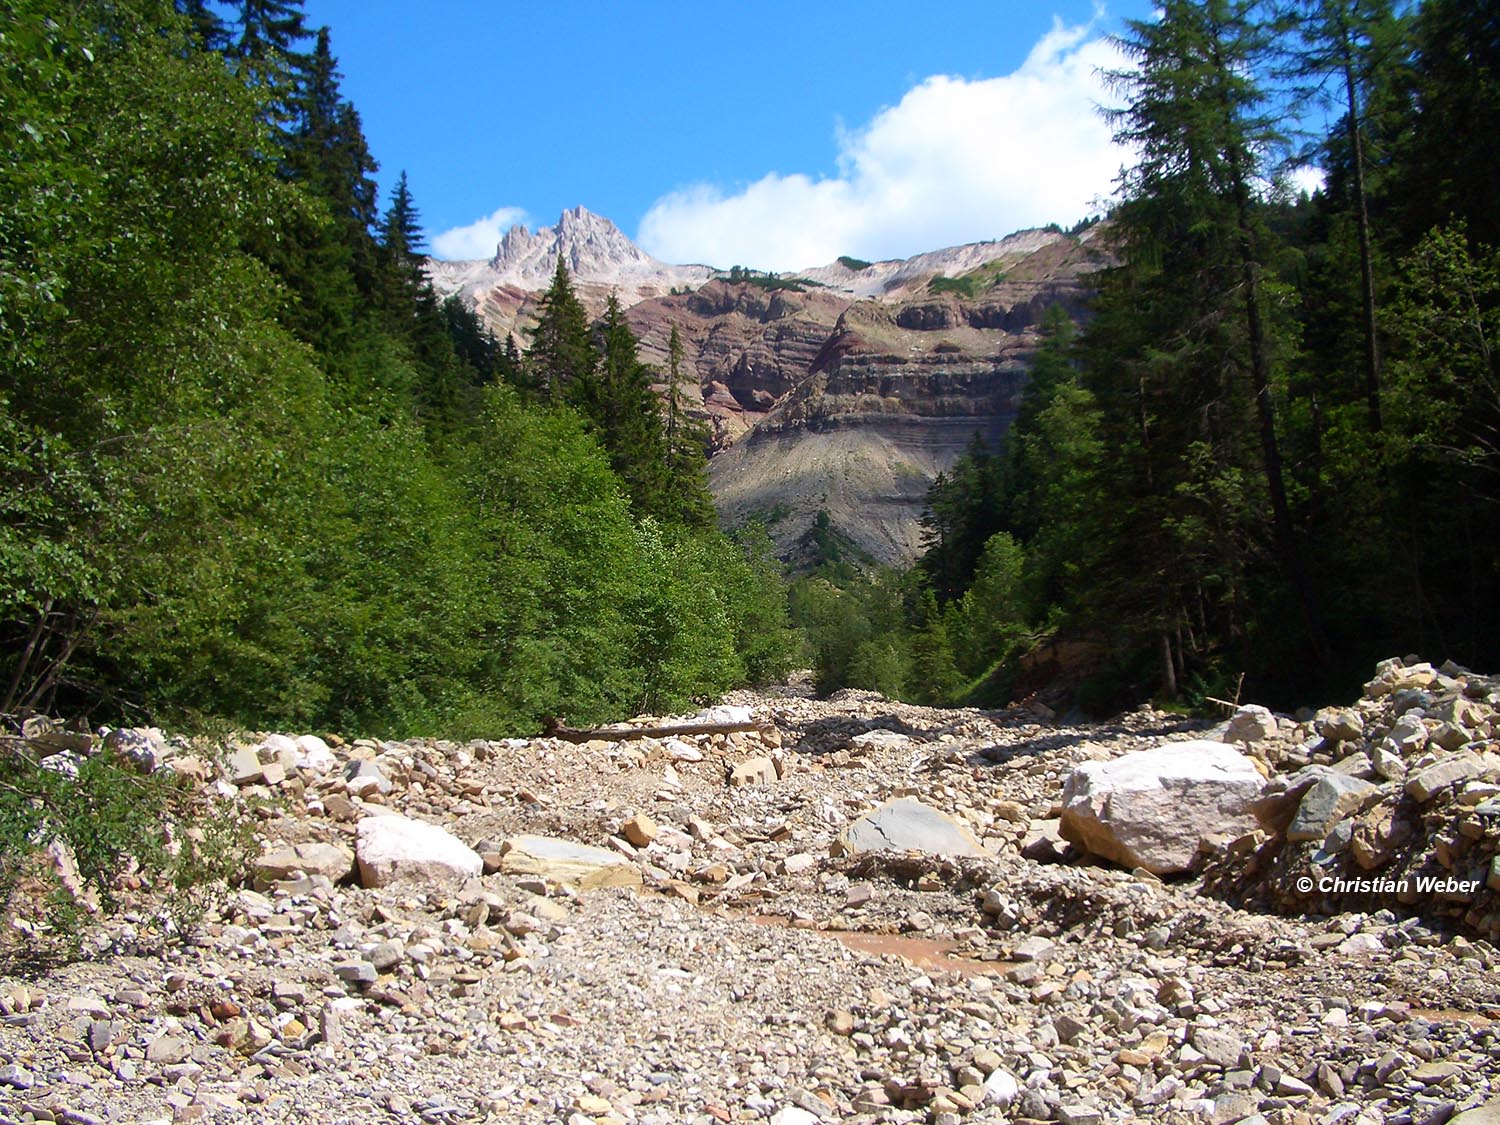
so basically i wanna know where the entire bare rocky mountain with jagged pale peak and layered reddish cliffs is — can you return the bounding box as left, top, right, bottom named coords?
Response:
left=429, top=209, right=1110, bottom=564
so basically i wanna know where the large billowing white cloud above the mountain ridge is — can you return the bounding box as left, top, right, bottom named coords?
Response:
left=641, top=21, right=1130, bottom=270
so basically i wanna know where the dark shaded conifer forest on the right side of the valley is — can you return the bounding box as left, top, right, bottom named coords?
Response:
left=797, top=0, right=1500, bottom=710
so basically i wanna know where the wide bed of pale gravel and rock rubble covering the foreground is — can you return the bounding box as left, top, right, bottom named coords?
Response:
left=0, top=663, right=1500, bottom=1125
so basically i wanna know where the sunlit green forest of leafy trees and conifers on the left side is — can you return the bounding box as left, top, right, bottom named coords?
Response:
left=0, top=0, right=792, bottom=735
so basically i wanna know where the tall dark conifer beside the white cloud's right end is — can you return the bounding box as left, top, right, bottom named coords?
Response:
left=1103, top=0, right=1328, bottom=690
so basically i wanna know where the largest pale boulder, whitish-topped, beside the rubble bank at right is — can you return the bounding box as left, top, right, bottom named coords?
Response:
left=1059, top=741, right=1265, bottom=875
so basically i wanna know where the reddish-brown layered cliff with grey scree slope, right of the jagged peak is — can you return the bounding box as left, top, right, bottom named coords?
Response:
left=699, top=236, right=1103, bottom=564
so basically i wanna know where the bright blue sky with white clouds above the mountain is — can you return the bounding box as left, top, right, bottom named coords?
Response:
left=295, top=0, right=1151, bottom=270
